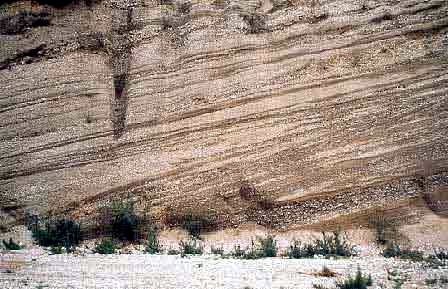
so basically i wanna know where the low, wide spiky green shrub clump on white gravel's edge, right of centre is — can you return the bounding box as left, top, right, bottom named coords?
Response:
left=287, top=231, right=355, bottom=259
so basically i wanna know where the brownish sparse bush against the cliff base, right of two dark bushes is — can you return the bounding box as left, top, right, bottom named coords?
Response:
left=166, top=209, right=217, bottom=239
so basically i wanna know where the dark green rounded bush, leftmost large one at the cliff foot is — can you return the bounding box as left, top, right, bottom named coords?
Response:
left=32, top=219, right=81, bottom=251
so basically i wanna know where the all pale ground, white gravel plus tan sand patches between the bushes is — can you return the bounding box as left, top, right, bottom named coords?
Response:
left=0, top=215, right=448, bottom=289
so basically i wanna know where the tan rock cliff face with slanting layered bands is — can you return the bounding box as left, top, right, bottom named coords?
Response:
left=0, top=0, right=448, bottom=227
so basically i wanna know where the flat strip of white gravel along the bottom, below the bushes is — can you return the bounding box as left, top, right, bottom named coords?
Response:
left=0, top=248, right=448, bottom=289
